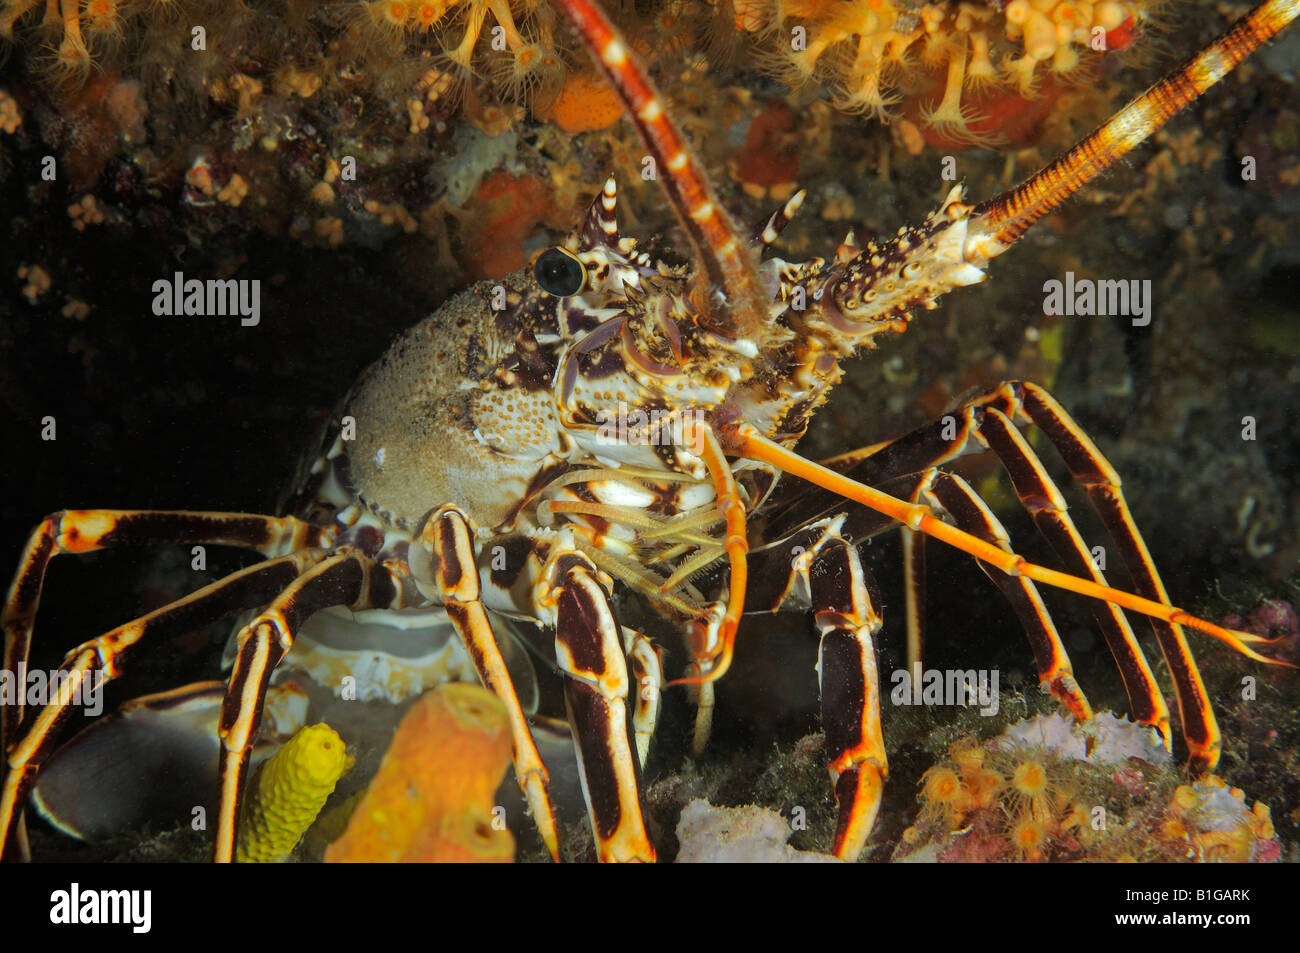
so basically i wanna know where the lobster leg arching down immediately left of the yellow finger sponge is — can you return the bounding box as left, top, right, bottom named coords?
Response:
left=212, top=550, right=374, bottom=863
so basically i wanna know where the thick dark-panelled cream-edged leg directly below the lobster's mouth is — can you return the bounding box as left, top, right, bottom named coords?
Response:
left=540, top=551, right=655, bottom=862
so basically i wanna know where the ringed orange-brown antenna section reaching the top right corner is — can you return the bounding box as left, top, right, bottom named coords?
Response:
left=971, top=0, right=1300, bottom=250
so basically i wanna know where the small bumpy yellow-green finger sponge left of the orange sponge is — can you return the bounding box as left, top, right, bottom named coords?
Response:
left=235, top=724, right=352, bottom=863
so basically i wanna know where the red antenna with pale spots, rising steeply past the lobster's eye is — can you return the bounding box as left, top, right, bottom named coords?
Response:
left=556, top=0, right=768, bottom=337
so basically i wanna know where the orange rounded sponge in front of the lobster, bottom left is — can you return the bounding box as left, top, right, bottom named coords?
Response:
left=325, top=684, right=515, bottom=863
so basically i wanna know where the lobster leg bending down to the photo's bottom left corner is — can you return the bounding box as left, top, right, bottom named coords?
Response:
left=0, top=550, right=325, bottom=859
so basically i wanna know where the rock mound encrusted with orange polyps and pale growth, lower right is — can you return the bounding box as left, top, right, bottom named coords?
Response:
left=894, top=712, right=1281, bottom=863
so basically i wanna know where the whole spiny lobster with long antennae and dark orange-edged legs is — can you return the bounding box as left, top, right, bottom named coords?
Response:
left=0, top=0, right=1300, bottom=861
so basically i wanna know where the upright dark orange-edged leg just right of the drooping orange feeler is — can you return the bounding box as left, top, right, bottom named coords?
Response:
left=811, top=540, right=889, bottom=861
